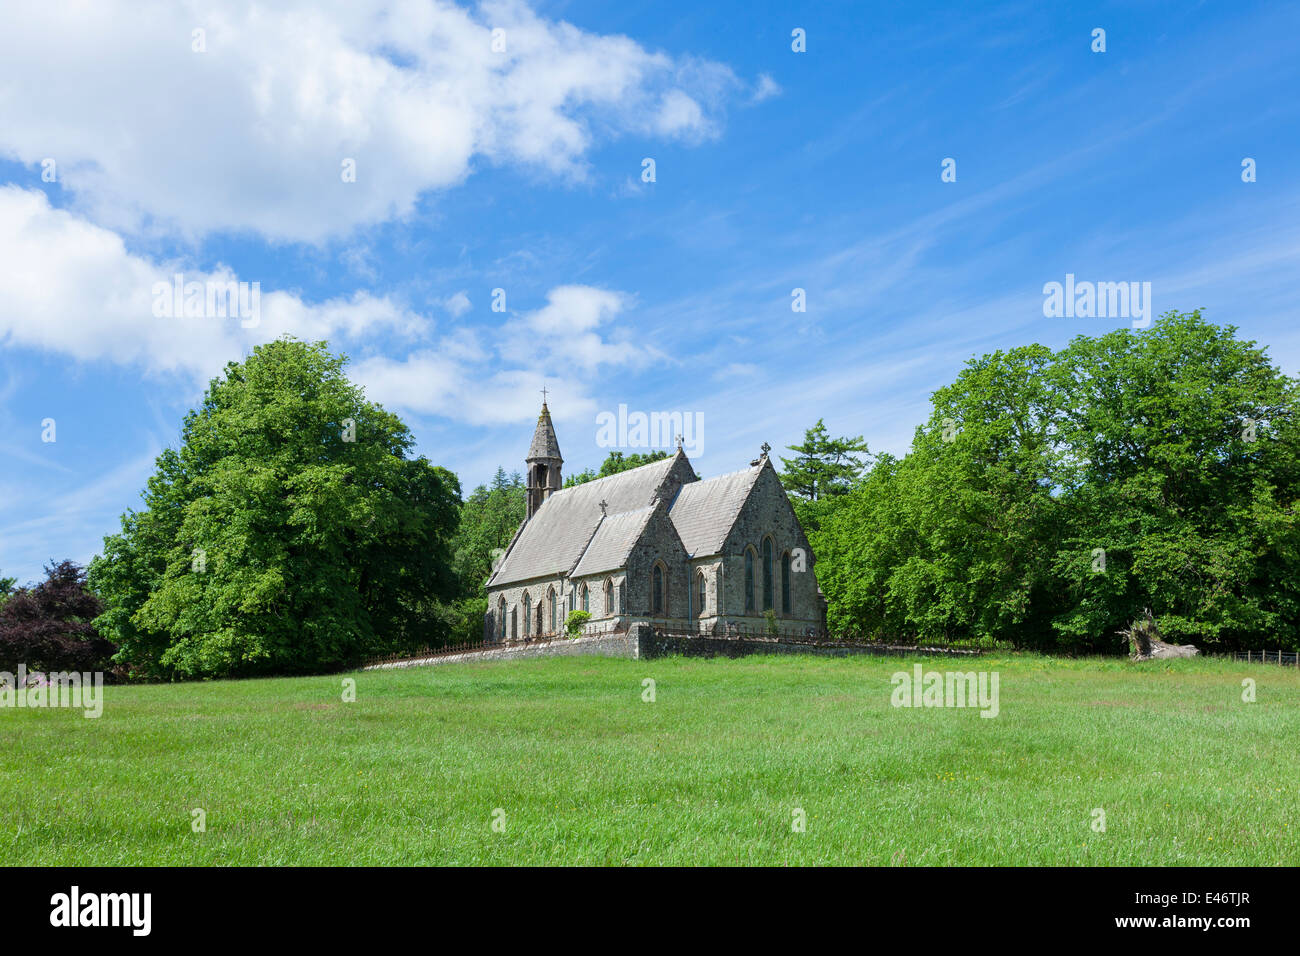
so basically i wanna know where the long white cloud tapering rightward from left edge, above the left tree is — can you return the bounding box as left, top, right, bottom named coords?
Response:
left=0, top=186, right=426, bottom=381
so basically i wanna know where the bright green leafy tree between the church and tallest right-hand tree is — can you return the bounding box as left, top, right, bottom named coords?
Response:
left=810, top=346, right=1056, bottom=639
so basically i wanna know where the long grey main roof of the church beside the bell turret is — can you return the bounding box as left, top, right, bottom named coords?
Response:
left=488, top=455, right=676, bottom=588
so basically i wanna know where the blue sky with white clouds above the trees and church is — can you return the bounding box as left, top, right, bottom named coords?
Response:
left=0, top=0, right=1300, bottom=580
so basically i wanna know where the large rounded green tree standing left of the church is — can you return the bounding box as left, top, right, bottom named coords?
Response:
left=90, top=339, right=460, bottom=678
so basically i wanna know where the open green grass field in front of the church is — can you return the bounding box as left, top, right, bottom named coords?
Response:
left=0, top=656, right=1300, bottom=865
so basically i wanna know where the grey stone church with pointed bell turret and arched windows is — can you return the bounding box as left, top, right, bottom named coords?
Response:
left=485, top=402, right=826, bottom=641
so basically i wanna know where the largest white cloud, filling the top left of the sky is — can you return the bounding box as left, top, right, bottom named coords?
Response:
left=0, top=0, right=738, bottom=242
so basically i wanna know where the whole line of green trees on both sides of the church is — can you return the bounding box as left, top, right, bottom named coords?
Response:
left=0, top=312, right=1300, bottom=679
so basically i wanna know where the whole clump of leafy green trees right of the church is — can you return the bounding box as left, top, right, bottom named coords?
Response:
left=810, top=312, right=1300, bottom=650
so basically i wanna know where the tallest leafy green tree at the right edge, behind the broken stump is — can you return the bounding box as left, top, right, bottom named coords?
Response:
left=1052, top=312, right=1300, bottom=645
